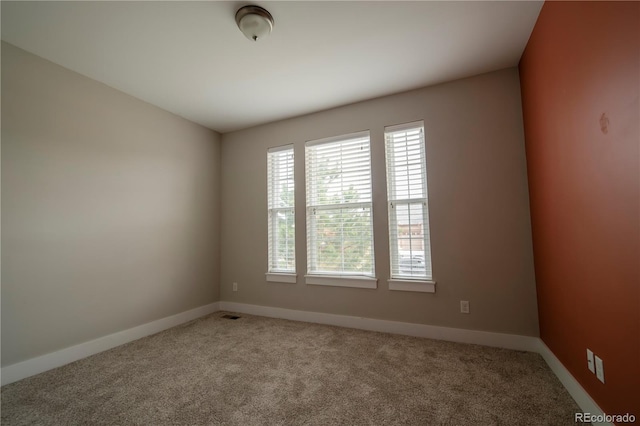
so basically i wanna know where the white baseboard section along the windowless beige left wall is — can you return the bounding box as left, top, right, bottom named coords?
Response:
left=0, top=302, right=220, bottom=385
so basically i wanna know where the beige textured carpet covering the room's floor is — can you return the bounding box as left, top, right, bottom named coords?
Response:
left=1, top=312, right=579, bottom=426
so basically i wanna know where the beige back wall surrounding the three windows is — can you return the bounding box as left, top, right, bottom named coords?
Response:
left=221, top=68, right=538, bottom=336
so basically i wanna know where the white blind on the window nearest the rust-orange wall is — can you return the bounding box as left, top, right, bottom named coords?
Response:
left=385, top=121, right=433, bottom=280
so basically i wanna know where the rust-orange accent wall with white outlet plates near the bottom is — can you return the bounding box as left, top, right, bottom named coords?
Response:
left=519, top=2, right=640, bottom=419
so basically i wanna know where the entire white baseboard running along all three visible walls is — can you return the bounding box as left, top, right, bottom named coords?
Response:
left=0, top=301, right=611, bottom=426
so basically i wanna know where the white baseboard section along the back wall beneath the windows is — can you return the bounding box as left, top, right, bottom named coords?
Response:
left=220, top=302, right=540, bottom=352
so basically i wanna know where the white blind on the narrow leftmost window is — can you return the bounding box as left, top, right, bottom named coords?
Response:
left=267, top=145, right=296, bottom=273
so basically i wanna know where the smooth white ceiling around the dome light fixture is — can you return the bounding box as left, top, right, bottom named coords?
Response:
left=1, top=1, right=542, bottom=133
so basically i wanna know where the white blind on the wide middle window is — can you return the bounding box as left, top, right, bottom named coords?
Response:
left=306, top=132, right=374, bottom=277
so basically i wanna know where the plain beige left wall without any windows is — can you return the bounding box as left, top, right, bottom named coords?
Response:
left=2, top=43, right=220, bottom=366
